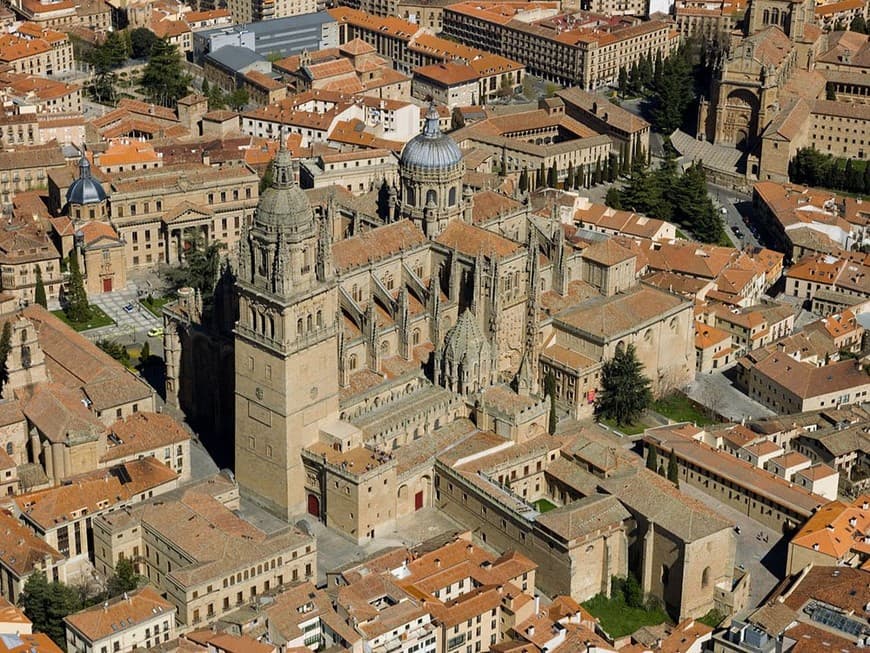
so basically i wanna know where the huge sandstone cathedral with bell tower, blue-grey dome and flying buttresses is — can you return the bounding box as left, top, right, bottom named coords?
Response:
left=165, top=107, right=694, bottom=528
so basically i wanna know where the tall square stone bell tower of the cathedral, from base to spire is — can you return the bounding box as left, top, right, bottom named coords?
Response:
left=235, top=139, right=338, bottom=517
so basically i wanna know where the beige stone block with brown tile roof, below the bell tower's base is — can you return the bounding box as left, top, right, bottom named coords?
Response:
left=93, top=475, right=317, bottom=630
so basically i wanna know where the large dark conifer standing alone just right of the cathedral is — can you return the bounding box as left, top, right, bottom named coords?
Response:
left=596, top=345, right=652, bottom=426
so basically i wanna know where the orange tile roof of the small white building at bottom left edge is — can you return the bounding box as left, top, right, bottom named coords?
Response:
left=64, top=587, right=175, bottom=642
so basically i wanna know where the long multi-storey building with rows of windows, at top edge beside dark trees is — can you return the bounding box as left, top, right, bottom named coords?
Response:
left=444, top=2, right=680, bottom=90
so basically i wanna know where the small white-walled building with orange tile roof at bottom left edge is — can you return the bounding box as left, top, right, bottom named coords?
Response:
left=63, top=587, right=178, bottom=653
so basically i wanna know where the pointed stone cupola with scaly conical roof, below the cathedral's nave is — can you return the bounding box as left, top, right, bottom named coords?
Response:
left=436, top=309, right=492, bottom=395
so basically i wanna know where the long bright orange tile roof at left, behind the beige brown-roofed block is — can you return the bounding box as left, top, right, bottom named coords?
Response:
left=15, top=457, right=178, bottom=531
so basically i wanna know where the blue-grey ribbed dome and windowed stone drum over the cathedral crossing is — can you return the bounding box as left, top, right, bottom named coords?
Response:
left=399, top=103, right=465, bottom=238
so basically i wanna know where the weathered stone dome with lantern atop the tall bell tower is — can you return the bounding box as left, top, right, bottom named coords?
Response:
left=254, top=138, right=314, bottom=237
